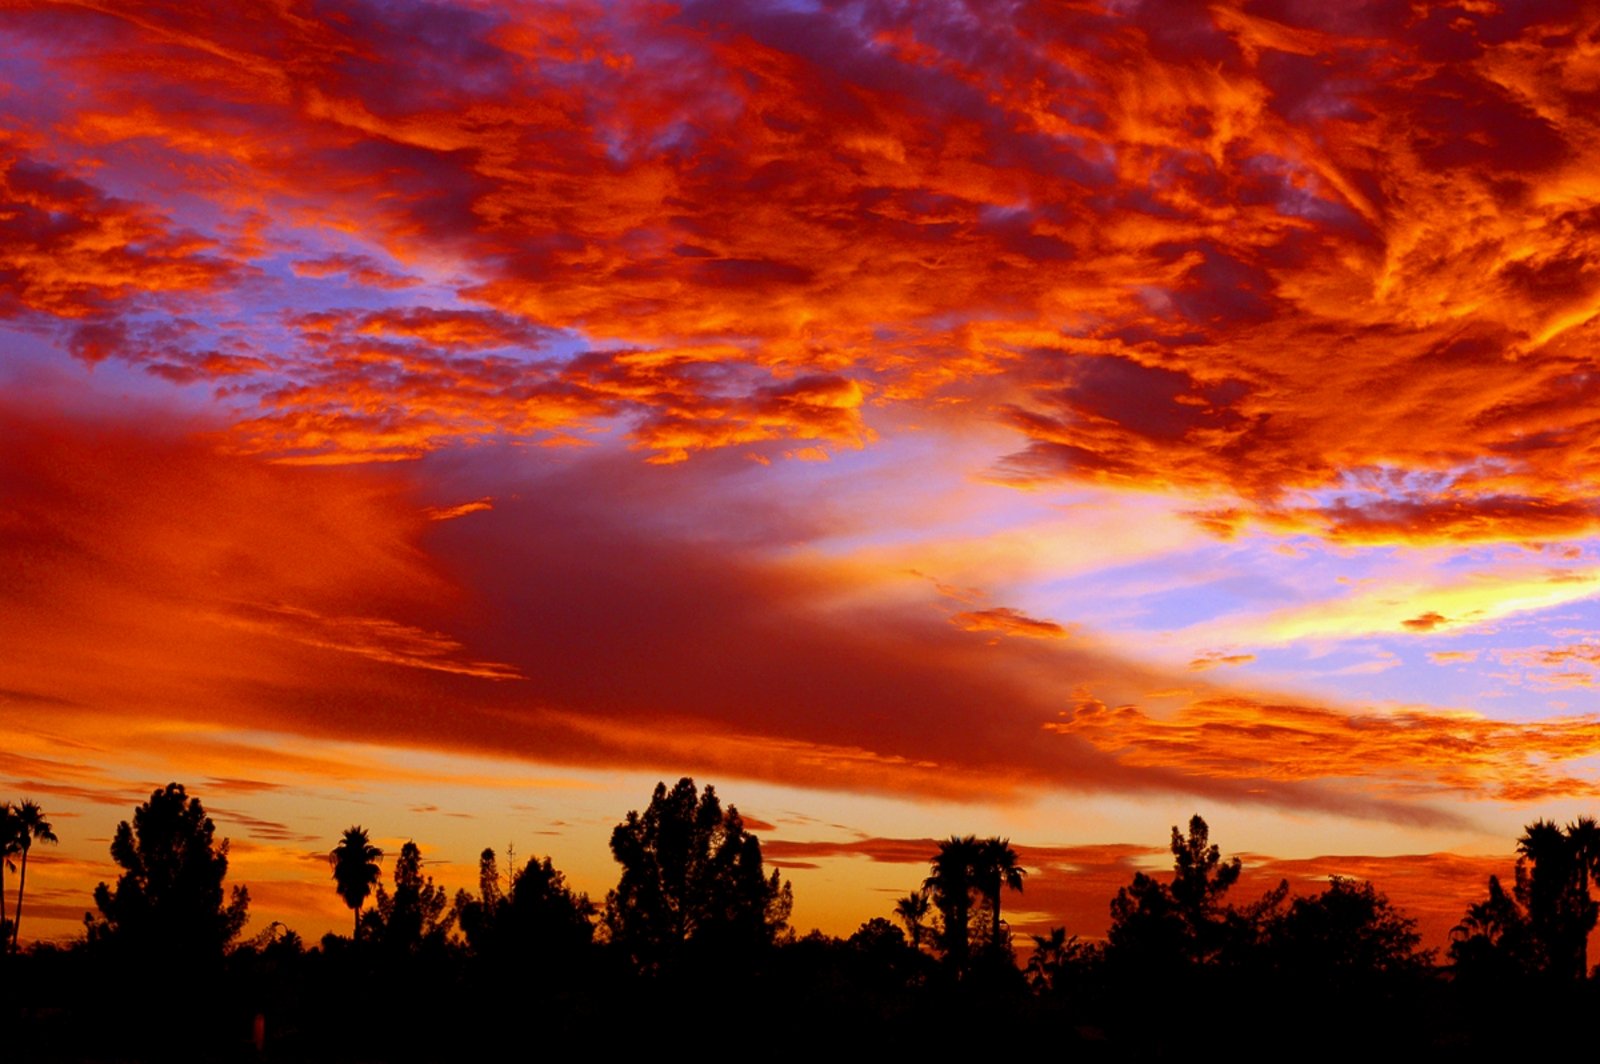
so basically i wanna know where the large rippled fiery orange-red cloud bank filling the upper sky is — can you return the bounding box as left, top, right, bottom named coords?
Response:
left=0, top=0, right=1600, bottom=544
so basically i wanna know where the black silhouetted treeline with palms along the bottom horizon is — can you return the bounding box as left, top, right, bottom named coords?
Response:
left=9, top=779, right=1600, bottom=1061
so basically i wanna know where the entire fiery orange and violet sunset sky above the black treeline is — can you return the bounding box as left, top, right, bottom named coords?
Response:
left=0, top=0, right=1600, bottom=946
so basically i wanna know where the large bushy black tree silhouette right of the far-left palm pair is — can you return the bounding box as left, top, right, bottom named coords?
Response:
left=86, top=782, right=250, bottom=965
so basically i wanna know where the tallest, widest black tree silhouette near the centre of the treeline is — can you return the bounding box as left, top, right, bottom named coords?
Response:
left=603, top=778, right=794, bottom=971
